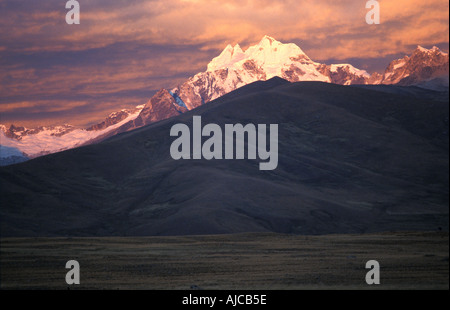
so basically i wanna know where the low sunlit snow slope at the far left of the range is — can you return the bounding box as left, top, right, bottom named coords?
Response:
left=0, top=106, right=144, bottom=164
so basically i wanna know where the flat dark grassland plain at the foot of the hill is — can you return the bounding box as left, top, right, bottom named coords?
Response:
left=0, top=232, right=449, bottom=290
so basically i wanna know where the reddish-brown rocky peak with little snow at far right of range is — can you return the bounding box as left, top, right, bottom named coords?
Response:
left=373, top=46, right=449, bottom=86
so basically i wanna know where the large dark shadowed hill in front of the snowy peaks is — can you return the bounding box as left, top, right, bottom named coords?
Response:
left=0, top=77, right=449, bottom=237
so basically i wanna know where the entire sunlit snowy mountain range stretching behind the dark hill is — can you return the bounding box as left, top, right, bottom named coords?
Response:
left=0, top=36, right=449, bottom=165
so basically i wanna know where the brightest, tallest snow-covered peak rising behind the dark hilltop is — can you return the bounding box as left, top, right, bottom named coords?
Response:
left=172, top=36, right=370, bottom=109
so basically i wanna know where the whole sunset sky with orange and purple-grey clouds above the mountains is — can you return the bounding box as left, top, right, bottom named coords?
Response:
left=0, top=0, right=449, bottom=127
